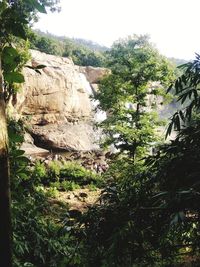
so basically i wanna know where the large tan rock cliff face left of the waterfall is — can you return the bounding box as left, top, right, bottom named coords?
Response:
left=15, top=51, right=108, bottom=150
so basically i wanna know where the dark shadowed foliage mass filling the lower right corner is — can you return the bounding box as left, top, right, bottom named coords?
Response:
left=72, top=53, right=200, bottom=267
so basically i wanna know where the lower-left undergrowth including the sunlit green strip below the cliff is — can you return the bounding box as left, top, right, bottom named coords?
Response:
left=9, top=120, right=103, bottom=267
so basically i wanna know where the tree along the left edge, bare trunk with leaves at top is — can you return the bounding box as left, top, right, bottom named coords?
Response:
left=0, top=0, right=58, bottom=267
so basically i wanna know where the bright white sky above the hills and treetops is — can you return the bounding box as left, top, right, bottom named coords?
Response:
left=34, top=0, right=200, bottom=60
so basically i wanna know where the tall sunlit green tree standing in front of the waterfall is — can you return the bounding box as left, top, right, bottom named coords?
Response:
left=96, top=35, right=172, bottom=159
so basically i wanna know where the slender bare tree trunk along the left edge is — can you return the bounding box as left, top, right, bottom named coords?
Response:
left=0, top=58, right=12, bottom=267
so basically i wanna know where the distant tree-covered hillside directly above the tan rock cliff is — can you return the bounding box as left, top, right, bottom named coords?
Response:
left=29, top=31, right=108, bottom=67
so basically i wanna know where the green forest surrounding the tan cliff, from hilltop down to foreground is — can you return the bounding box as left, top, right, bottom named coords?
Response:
left=0, top=0, right=200, bottom=267
